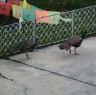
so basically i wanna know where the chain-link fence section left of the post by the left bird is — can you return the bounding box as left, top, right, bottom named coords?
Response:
left=0, top=22, right=34, bottom=56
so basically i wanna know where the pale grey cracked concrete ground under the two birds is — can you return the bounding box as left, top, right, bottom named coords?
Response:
left=0, top=37, right=96, bottom=95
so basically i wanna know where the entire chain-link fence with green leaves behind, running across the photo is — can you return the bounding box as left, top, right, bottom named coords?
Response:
left=0, top=6, right=96, bottom=56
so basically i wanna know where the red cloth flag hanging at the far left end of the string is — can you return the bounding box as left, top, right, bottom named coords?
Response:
left=0, top=2, right=11, bottom=16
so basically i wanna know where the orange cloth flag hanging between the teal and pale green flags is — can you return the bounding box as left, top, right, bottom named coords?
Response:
left=36, top=10, right=48, bottom=23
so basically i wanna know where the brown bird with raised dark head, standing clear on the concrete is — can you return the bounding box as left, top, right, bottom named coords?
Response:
left=59, top=32, right=87, bottom=55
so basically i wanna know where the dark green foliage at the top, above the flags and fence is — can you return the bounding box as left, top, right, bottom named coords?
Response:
left=27, top=0, right=96, bottom=11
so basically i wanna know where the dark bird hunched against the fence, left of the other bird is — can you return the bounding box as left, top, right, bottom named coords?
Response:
left=8, top=39, right=37, bottom=59
